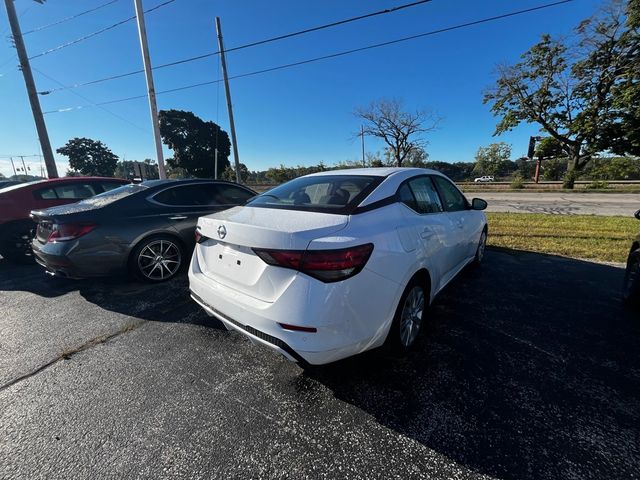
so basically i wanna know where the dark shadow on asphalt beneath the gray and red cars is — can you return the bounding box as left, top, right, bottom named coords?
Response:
left=0, top=259, right=220, bottom=330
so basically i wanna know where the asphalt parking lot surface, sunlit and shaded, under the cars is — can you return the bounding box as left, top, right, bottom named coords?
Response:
left=0, top=250, right=640, bottom=479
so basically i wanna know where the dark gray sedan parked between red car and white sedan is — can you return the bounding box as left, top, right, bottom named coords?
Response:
left=32, top=180, right=256, bottom=282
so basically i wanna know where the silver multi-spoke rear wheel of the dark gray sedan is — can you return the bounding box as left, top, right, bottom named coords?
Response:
left=131, top=235, right=184, bottom=282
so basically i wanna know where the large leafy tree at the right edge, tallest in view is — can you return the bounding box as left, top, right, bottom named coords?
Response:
left=484, top=0, right=640, bottom=188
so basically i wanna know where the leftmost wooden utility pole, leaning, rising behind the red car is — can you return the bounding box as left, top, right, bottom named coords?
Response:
left=4, top=0, right=58, bottom=178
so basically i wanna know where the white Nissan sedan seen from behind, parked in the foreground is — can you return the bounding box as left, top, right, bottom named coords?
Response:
left=189, top=168, right=487, bottom=365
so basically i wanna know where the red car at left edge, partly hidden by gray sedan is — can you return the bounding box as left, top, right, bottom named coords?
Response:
left=0, top=177, right=131, bottom=262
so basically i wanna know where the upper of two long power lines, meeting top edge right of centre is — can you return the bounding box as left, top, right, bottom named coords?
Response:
left=38, top=0, right=433, bottom=95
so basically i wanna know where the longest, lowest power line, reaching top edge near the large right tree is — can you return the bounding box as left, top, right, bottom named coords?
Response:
left=44, top=0, right=575, bottom=114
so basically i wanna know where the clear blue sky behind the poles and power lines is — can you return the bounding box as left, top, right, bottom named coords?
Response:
left=0, top=0, right=602, bottom=176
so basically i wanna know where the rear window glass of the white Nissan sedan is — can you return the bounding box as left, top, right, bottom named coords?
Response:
left=247, top=175, right=384, bottom=215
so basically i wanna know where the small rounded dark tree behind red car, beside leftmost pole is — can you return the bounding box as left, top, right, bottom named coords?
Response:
left=56, top=137, right=118, bottom=177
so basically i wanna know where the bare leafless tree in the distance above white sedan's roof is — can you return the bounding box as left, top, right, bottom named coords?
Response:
left=353, top=99, right=440, bottom=167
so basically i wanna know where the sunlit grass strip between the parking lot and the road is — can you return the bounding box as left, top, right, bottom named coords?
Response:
left=487, top=213, right=640, bottom=262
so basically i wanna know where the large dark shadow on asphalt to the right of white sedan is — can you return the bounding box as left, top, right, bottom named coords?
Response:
left=298, top=250, right=640, bottom=479
